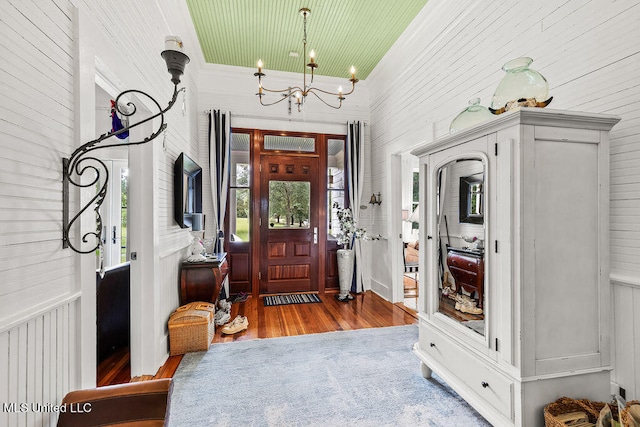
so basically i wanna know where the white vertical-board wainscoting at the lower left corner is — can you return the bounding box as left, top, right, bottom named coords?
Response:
left=0, top=300, right=76, bottom=427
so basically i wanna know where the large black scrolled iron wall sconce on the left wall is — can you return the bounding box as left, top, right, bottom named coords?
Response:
left=62, top=36, right=189, bottom=258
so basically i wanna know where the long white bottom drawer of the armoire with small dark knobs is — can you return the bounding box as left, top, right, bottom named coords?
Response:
left=420, top=322, right=513, bottom=419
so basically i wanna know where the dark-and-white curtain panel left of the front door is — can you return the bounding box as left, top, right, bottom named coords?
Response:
left=209, top=110, right=231, bottom=252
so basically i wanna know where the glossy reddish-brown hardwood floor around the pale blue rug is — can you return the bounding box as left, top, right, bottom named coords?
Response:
left=98, top=291, right=417, bottom=385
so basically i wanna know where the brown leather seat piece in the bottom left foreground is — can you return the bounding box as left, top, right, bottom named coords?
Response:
left=58, top=379, right=173, bottom=427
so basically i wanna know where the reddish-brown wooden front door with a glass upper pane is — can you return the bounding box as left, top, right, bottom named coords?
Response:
left=259, top=154, right=320, bottom=294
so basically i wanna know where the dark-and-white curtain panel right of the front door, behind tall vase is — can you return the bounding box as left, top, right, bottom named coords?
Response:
left=347, top=122, right=364, bottom=293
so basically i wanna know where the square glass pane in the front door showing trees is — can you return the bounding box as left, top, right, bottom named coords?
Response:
left=269, top=181, right=311, bottom=229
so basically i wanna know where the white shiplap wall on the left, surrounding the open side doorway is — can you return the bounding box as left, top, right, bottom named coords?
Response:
left=0, top=0, right=202, bottom=426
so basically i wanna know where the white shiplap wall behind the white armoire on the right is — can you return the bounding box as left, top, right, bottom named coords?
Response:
left=367, top=0, right=640, bottom=399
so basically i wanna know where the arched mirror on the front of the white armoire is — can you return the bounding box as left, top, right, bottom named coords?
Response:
left=434, top=158, right=487, bottom=335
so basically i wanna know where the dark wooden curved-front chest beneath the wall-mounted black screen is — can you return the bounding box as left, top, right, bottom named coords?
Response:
left=180, top=252, right=229, bottom=305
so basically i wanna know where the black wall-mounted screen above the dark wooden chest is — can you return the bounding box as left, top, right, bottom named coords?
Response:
left=173, top=153, right=202, bottom=228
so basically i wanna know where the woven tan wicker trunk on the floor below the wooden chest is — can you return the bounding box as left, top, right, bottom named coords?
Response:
left=169, top=301, right=215, bottom=356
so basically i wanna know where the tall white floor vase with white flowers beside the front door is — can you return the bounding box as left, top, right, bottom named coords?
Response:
left=333, top=203, right=367, bottom=302
